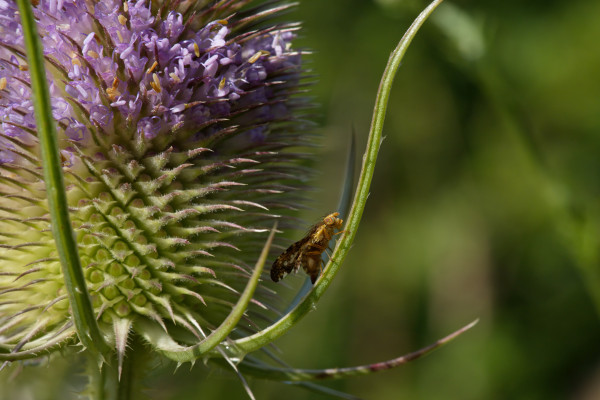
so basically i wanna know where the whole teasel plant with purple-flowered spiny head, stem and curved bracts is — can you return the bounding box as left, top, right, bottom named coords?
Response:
left=0, top=0, right=474, bottom=399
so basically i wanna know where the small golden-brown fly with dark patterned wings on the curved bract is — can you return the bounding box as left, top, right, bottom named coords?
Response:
left=271, top=212, right=345, bottom=284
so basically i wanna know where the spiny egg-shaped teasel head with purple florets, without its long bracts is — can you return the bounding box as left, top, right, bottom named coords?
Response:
left=0, top=0, right=312, bottom=368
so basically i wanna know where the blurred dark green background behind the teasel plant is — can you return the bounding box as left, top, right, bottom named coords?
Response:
left=165, top=0, right=600, bottom=400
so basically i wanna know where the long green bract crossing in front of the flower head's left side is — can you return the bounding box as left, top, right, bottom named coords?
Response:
left=17, top=0, right=109, bottom=353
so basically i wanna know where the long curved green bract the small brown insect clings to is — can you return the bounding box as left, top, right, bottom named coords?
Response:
left=231, top=0, right=442, bottom=356
